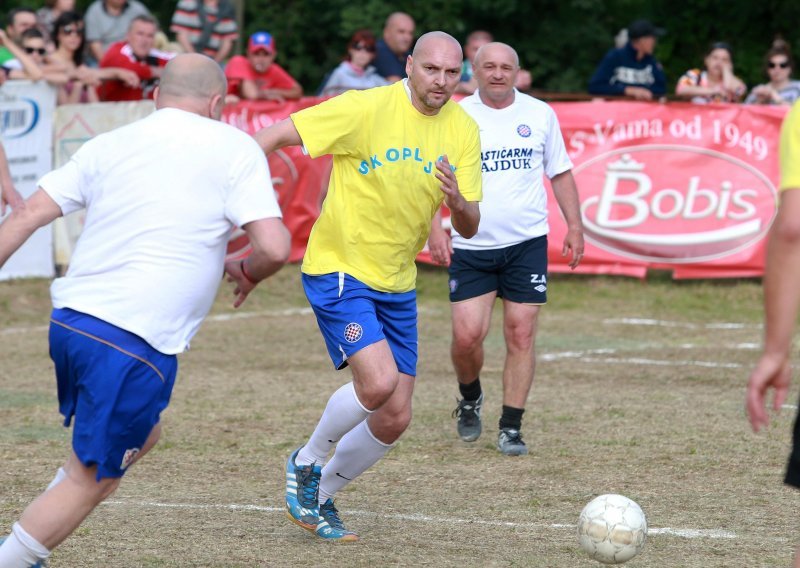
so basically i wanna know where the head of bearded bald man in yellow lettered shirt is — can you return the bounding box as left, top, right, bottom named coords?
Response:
left=406, top=38, right=462, bottom=115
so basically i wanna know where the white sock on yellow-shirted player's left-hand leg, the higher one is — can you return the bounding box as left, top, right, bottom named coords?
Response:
left=295, top=381, right=372, bottom=465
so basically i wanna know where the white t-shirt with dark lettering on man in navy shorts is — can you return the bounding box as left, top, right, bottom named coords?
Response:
left=452, top=90, right=572, bottom=250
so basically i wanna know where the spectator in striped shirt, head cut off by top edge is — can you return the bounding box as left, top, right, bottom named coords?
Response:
left=170, top=0, right=239, bottom=63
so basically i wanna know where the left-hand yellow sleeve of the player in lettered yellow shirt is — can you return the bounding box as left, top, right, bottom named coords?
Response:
left=290, top=91, right=368, bottom=158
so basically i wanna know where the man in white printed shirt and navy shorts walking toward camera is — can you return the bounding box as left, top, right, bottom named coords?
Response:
left=429, top=43, right=583, bottom=456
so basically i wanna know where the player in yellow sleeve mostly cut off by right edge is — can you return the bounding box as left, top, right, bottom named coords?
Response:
left=746, top=104, right=800, bottom=568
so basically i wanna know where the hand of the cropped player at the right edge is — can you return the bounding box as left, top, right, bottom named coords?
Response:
left=745, top=353, right=792, bottom=432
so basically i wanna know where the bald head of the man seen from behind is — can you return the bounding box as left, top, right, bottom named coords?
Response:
left=156, top=53, right=227, bottom=114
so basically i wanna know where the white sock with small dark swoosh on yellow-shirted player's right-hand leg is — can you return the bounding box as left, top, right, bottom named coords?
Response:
left=319, top=420, right=394, bottom=504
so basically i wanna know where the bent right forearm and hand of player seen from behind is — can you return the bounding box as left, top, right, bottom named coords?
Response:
left=225, top=217, right=291, bottom=308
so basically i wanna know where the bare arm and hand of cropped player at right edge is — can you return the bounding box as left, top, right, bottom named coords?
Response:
left=746, top=189, right=800, bottom=432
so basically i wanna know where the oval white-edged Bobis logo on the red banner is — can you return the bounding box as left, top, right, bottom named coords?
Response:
left=573, top=145, right=777, bottom=264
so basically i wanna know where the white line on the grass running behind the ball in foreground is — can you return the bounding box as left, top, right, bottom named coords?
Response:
left=103, top=501, right=737, bottom=539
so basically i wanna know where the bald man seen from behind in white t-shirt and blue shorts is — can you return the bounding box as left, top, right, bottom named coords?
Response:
left=0, top=54, right=289, bottom=568
